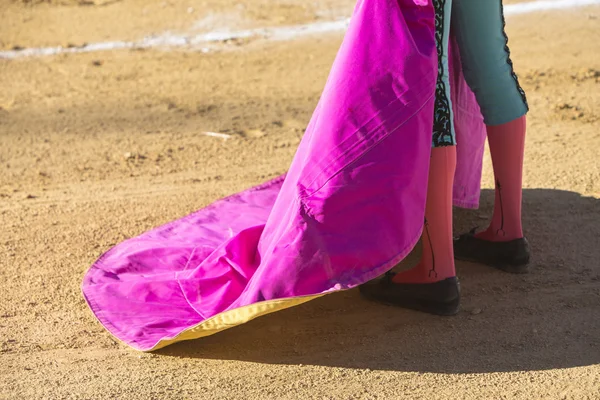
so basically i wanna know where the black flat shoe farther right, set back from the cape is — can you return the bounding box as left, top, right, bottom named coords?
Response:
left=454, top=229, right=530, bottom=274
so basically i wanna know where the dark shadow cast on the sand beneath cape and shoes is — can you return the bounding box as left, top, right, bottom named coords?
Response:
left=157, top=189, right=600, bottom=373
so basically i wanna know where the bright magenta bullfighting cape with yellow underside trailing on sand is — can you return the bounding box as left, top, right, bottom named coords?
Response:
left=83, top=0, right=485, bottom=350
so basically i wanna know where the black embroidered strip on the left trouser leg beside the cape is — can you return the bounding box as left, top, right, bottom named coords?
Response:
left=433, top=0, right=456, bottom=147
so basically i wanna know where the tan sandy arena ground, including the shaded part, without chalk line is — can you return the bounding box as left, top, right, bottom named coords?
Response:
left=0, top=0, right=600, bottom=399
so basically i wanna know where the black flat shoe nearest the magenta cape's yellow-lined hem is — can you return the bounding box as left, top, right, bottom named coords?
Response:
left=360, top=272, right=460, bottom=315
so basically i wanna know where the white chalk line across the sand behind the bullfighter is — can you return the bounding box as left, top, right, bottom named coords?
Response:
left=0, top=0, right=600, bottom=59
